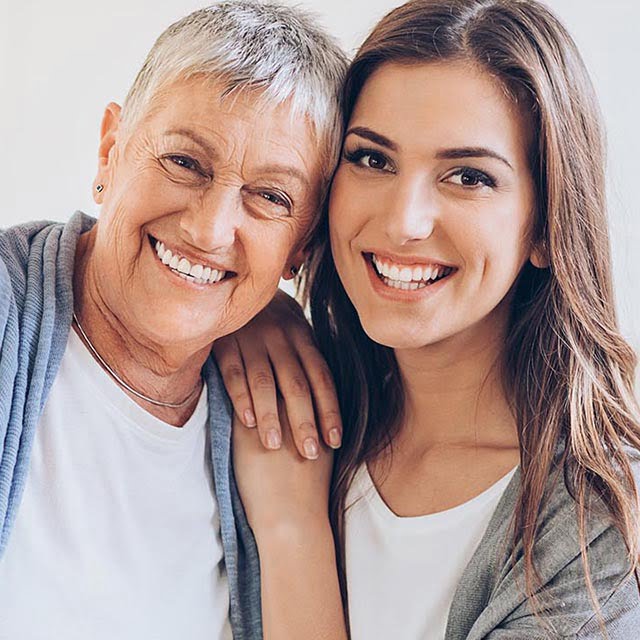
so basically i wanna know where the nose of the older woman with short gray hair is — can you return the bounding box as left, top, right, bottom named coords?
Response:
left=180, top=184, right=242, bottom=253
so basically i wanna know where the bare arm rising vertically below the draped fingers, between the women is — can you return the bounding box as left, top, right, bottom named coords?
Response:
left=233, top=408, right=347, bottom=640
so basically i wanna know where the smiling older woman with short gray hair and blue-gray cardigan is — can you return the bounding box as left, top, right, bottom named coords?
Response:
left=0, top=2, right=345, bottom=640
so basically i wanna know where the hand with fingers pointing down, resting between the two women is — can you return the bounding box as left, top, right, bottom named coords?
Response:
left=213, top=292, right=342, bottom=459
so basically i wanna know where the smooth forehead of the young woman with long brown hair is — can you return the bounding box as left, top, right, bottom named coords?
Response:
left=350, top=62, right=530, bottom=156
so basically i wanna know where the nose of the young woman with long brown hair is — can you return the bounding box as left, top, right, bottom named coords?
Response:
left=385, top=176, right=437, bottom=246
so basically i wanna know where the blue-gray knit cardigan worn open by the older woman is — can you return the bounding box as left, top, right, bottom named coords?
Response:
left=0, top=213, right=262, bottom=640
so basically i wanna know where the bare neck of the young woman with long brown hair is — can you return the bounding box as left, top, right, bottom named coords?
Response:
left=396, top=312, right=518, bottom=452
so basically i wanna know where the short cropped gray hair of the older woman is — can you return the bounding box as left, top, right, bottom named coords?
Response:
left=122, top=0, right=347, bottom=180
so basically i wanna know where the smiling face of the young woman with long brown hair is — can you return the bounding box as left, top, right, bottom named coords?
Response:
left=330, top=62, right=535, bottom=349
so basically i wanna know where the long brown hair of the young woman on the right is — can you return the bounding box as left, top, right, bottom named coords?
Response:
left=306, top=0, right=640, bottom=632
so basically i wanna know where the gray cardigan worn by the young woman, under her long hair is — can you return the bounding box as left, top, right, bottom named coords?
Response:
left=445, top=462, right=640, bottom=640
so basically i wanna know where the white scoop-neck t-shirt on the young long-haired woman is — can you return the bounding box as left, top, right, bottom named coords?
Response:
left=345, top=465, right=515, bottom=640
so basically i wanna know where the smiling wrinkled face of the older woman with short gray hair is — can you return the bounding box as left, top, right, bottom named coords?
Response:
left=91, top=80, right=322, bottom=348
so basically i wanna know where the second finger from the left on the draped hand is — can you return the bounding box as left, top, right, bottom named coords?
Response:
left=238, top=338, right=282, bottom=449
